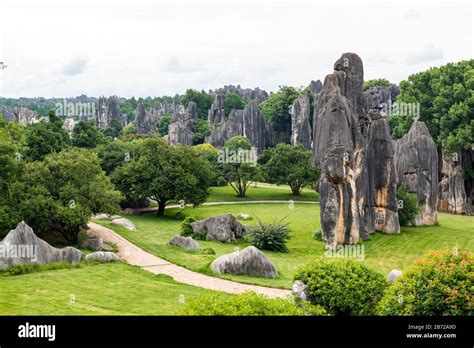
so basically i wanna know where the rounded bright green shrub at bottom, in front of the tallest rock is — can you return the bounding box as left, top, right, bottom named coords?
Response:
left=295, top=259, right=386, bottom=315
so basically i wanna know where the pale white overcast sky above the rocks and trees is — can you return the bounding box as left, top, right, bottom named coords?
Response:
left=0, top=0, right=473, bottom=97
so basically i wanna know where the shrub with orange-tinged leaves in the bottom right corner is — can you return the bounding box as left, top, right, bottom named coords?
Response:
left=378, top=249, right=474, bottom=316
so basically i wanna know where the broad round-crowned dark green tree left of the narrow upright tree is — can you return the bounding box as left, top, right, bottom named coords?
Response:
left=112, top=138, right=211, bottom=215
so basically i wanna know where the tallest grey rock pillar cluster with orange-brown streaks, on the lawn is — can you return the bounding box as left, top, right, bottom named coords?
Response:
left=313, top=53, right=400, bottom=248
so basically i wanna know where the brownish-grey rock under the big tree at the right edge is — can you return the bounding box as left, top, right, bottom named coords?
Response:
left=438, top=150, right=473, bottom=214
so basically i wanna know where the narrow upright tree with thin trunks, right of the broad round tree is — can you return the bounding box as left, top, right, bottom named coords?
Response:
left=219, top=135, right=257, bottom=197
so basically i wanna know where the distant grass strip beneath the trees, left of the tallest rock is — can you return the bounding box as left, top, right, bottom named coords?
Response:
left=207, top=184, right=319, bottom=202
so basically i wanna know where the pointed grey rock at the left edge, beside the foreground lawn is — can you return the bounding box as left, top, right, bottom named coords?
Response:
left=0, top=221, right=82, bottom=269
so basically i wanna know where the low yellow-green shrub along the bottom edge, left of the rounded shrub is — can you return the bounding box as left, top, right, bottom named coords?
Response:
left=180, top=291, right=327, bottom=316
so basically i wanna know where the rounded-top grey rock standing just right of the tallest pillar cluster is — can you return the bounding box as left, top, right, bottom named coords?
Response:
left=396, top=121, right=438, bottom=226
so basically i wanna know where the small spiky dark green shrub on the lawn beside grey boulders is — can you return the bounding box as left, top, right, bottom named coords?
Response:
left=248, top=220, right=290, bottom=252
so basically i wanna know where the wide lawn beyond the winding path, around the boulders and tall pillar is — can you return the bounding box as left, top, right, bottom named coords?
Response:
left=92, top=203, right=474, bottom=288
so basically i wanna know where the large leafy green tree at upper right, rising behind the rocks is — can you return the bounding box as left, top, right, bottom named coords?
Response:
left=389, top=59, right=474, bottom=151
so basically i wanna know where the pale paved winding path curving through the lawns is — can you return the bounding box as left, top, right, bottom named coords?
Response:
left=87, top=222, right=290, bottom=298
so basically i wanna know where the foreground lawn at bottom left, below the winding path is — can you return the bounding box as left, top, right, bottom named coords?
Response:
left=0, top=262, right=231, bottom=315
